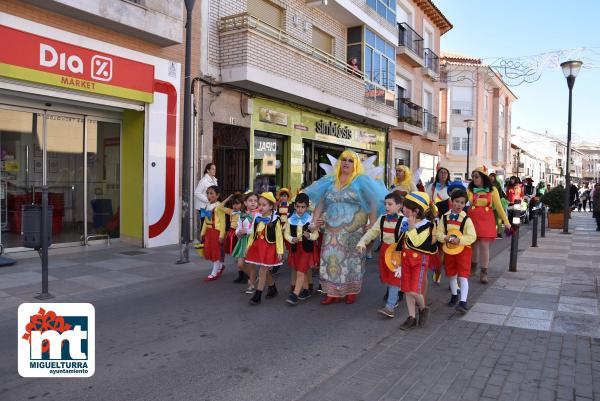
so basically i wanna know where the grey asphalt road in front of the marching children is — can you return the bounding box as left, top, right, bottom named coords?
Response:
left=0, top=225, right=529, bottom=401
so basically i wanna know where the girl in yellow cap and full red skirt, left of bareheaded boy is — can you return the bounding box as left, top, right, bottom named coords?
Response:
left=246, top=192, right=283, bottom=305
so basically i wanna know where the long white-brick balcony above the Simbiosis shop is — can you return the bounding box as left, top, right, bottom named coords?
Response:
left=219, top=13, right=396, bottom=127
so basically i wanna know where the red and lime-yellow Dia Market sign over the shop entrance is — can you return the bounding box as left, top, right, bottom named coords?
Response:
left=0, top=25, right=154, bottom=103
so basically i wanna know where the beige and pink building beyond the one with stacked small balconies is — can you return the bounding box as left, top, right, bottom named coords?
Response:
left=439, top=54, right=517, bottom=178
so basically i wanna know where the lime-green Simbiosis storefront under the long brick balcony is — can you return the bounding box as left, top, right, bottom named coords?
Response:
left=250, top=98, right=385, bottom=193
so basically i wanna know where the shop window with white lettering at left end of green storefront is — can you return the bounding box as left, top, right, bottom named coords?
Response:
left=253, top=131, right=284, bottom=194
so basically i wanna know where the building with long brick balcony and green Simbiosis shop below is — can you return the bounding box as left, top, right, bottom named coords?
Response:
left=196, top=0, right=398, bottom=194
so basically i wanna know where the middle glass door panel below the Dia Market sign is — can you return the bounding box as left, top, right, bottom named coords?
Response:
left=45, top=113, right=85, bottom=243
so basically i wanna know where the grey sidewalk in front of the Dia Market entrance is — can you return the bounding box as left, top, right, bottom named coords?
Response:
left=0, top=239, right=200, bottom=321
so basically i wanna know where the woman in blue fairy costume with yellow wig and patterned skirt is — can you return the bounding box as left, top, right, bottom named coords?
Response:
left=303, top=150, right=388, bottom=305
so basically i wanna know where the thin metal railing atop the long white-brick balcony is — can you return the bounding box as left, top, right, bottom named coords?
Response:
left=219, top=13, right=364, bottom=79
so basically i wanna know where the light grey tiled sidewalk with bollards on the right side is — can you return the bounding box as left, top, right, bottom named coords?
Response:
left=298, top=213, right=600, bottom=401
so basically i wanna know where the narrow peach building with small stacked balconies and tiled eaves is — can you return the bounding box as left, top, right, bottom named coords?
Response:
left=388, top=0, right=452, bottom=183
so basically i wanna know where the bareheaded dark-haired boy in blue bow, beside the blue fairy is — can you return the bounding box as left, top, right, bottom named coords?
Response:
left=284, top=193, right=319, bottom=305
